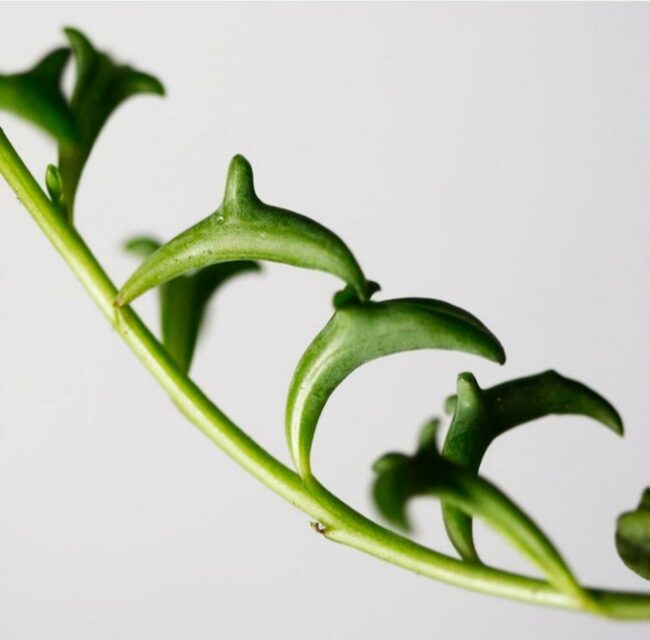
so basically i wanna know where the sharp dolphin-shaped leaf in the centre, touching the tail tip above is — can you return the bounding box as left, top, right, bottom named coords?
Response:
left=286, top=298, right=505, bottom=477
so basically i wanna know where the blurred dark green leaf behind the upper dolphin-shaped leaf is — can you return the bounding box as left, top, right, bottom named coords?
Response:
left=126, top=237, right=260, bottom=372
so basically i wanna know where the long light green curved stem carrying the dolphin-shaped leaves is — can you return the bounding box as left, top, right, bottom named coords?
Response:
left=0, top=129, right=650, bottom=620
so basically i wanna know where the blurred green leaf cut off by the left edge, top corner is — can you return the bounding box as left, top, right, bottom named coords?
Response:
left=0, top=48, right=75, bottom=142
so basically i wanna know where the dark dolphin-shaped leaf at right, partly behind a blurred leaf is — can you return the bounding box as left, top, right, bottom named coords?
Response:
left=442, top=371, right=623, bottom=562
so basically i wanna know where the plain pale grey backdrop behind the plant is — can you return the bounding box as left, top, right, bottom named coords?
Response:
left=0, top=4, right=650, bottom=640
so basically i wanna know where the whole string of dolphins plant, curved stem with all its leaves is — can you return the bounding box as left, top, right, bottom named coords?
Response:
left=0, top=29, right=650, bottom=620
